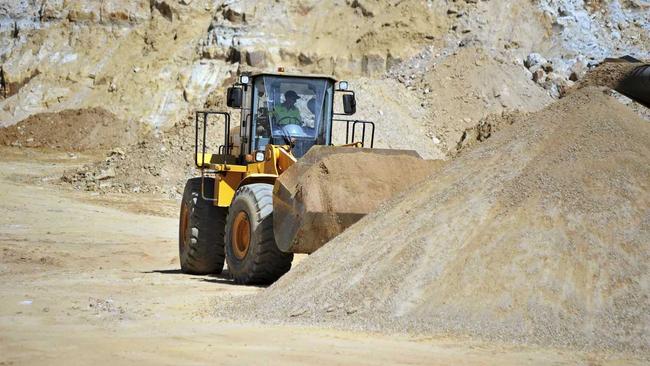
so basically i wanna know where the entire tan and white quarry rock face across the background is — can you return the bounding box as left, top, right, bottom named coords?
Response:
left=0, top=0, right=649, bottom=157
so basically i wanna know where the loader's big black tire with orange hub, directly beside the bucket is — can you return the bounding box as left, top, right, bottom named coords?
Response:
left=225, top=183, right=293, bottom=285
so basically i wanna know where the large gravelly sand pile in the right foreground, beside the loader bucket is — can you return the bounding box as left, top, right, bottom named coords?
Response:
left=225, top=88, right=650, bottom=354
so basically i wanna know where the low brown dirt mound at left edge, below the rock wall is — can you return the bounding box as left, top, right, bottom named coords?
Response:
left=0, top=108, right=137, bottom=151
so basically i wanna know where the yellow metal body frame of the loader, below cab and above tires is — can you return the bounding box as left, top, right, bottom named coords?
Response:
left=197, top=145, right=296, bottom=207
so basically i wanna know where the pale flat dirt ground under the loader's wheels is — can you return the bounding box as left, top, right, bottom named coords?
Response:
left=0, top=147, right=642, bottom=365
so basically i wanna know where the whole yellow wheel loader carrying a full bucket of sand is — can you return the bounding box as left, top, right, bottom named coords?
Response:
left=179, top=72, right=438, bottom=284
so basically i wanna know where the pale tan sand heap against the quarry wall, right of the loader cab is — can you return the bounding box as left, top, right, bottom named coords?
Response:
left=390, top=45, right=553, bottom=155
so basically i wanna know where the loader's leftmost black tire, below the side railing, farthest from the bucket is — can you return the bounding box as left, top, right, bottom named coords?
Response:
left=178, top=178, right=228, bottom=274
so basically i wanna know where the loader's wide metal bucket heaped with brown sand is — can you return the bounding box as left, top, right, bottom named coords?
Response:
left=273, top=146, right=442, bottom=253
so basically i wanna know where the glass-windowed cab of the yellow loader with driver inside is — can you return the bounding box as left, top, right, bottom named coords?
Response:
left=228, top=73, right=344, bottom=158
